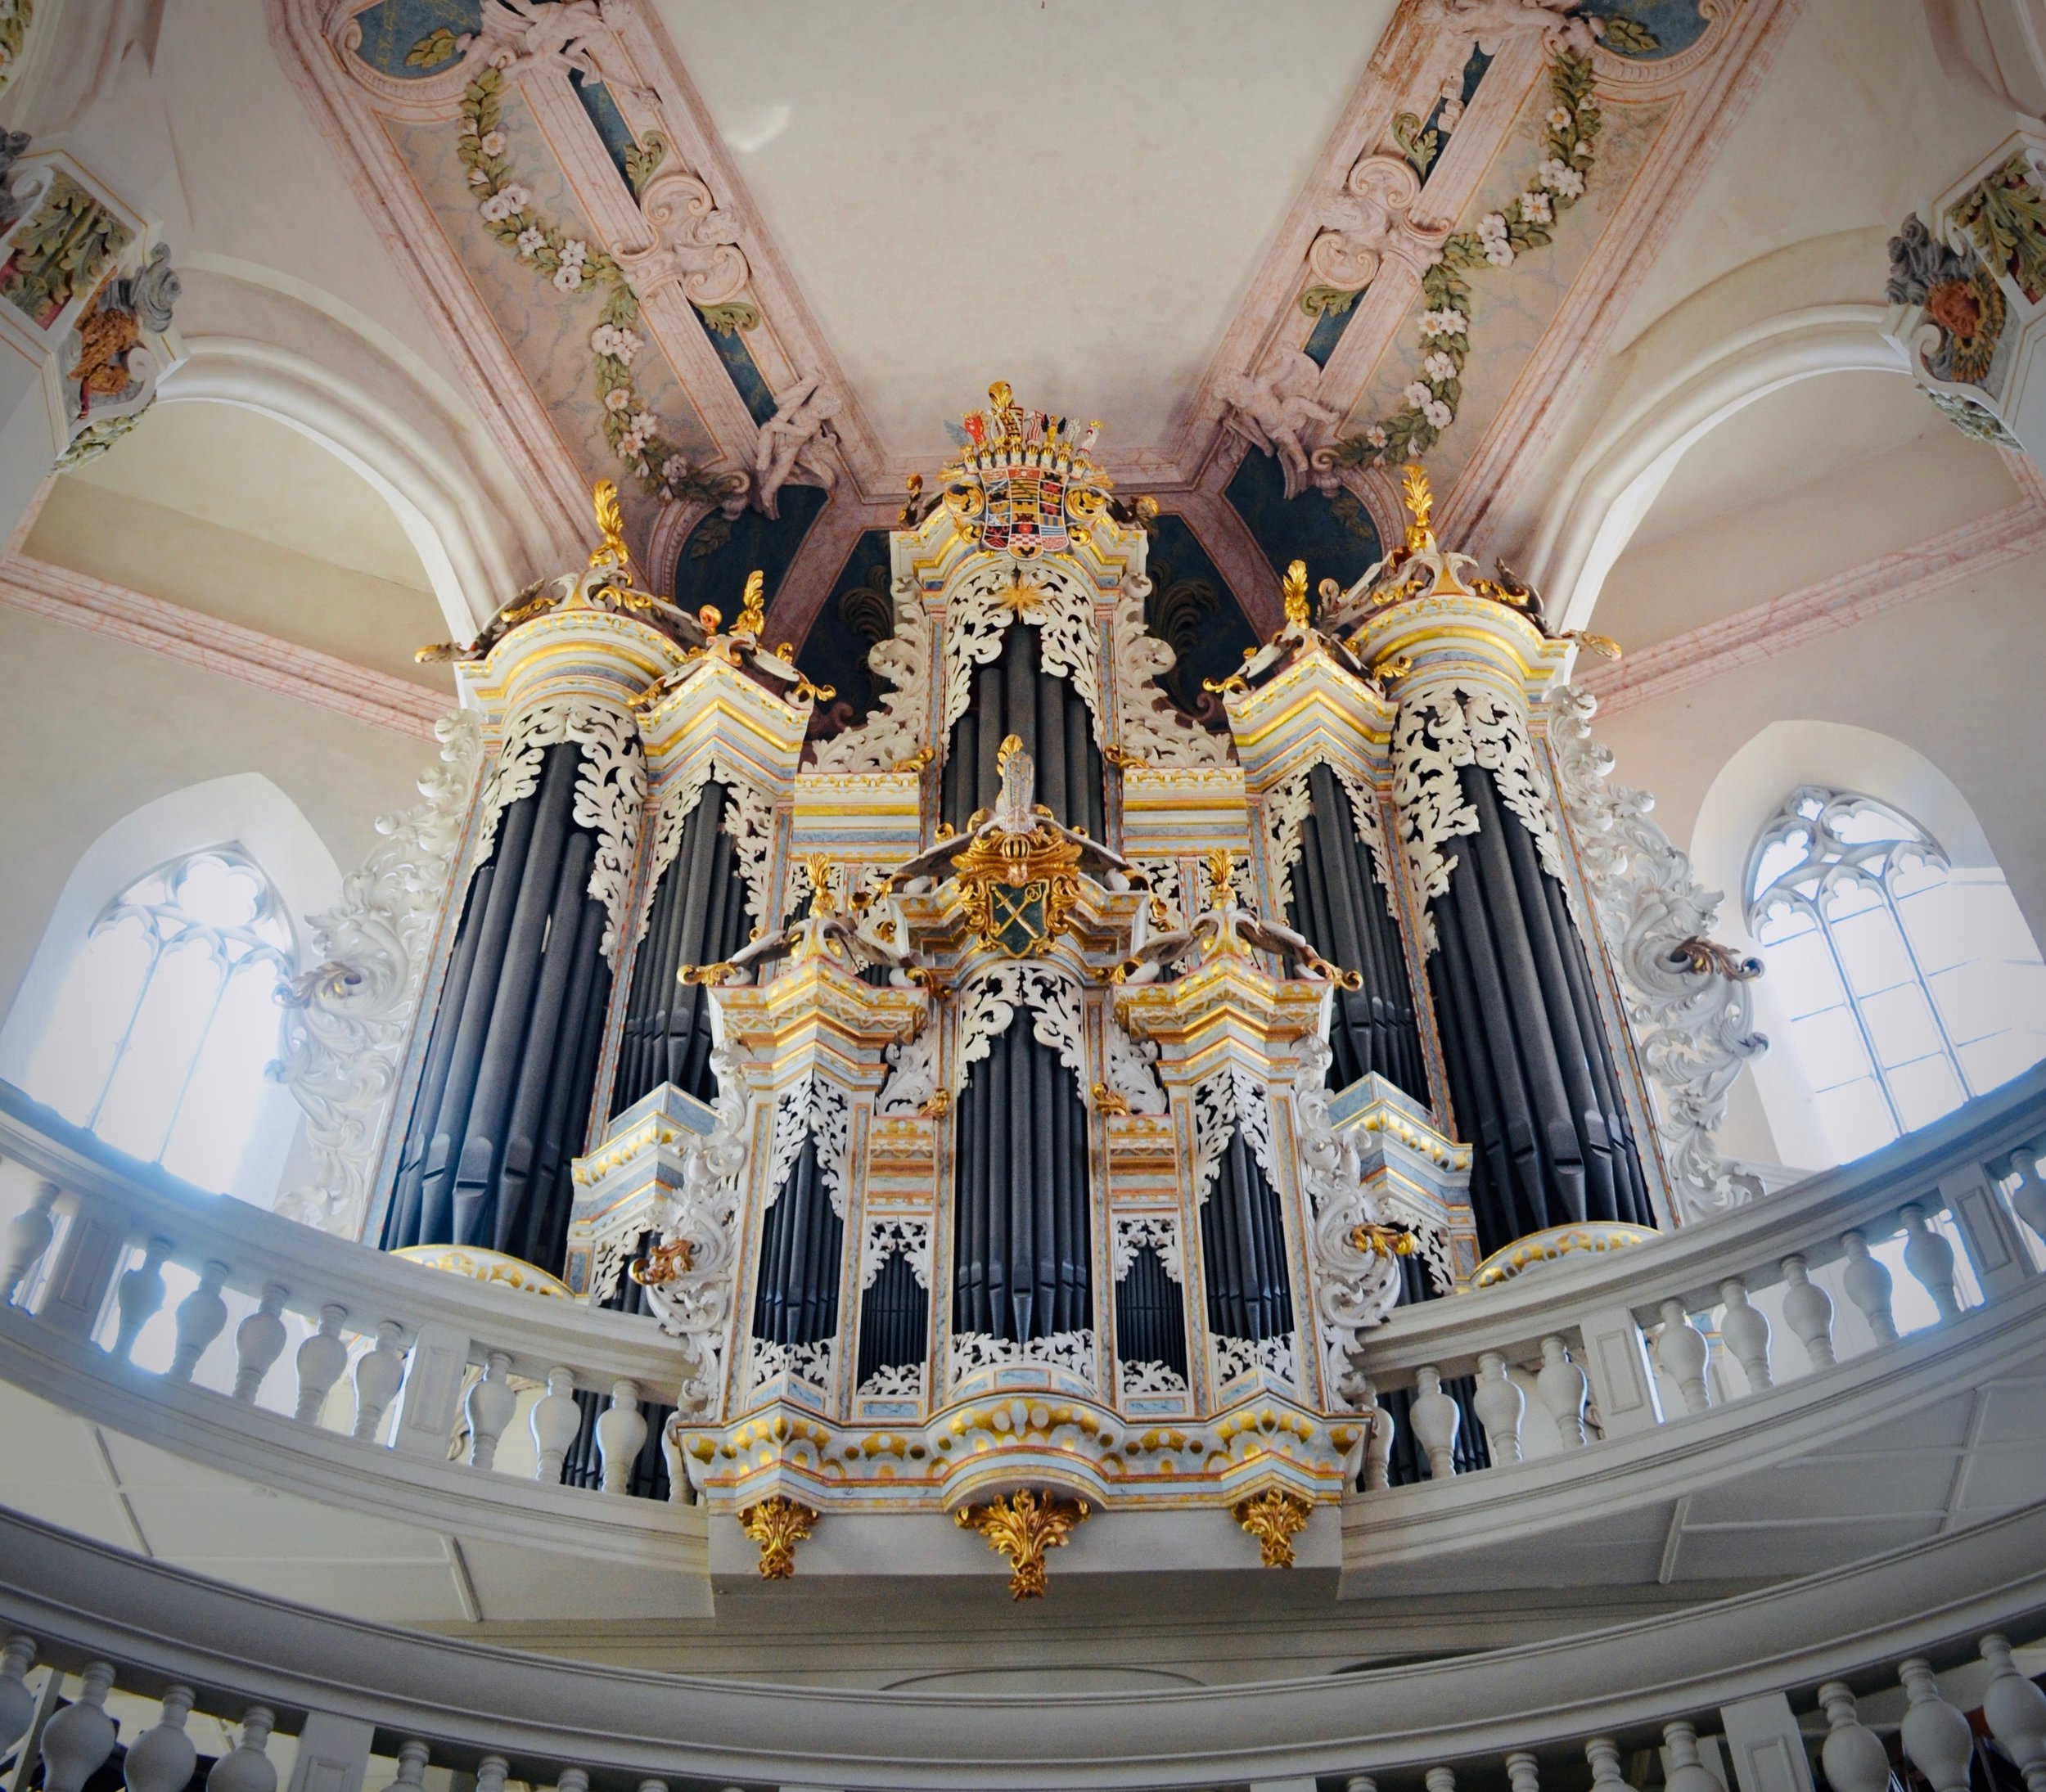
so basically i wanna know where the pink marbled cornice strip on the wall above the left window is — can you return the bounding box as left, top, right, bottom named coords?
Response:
left=0, top=555, right=448, bottom=741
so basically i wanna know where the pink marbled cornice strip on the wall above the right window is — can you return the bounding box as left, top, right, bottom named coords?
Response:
left=1582, top=491, right=2046, bottom=716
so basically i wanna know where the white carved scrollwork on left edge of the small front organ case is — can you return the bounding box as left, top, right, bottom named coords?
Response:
left=647, top=1046, right=747, bottom=1422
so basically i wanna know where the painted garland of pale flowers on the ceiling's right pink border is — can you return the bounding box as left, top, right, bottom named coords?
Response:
left=1330, top=49, right=1600, bottom=466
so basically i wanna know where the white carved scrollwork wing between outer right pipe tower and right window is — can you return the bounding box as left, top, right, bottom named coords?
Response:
left=1549, top=686, right=1768, bottom=1219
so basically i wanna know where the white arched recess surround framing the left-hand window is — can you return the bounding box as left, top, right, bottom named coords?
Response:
left=0, top=772, right=342, bottom=1207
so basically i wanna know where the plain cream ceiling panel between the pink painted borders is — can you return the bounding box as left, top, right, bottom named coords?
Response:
left=657, top=0, right=1394, bottom=457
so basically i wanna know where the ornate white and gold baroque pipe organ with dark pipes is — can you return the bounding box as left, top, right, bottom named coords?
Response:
left=368, top=387, right=1694, bottom=1596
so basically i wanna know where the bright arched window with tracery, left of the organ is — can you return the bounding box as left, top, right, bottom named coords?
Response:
left=29, top=847, right=295, bottom=1193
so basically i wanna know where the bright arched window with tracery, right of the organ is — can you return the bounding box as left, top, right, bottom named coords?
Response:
left=1746, top=784, right=2046, bottom=1160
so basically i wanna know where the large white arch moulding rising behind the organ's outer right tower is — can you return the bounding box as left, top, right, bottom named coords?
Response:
left=1533, top=305, right=1911, bottom=628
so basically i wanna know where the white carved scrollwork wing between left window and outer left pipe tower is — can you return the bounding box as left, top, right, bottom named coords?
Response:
left=268, top=710, right=483, bottom=1238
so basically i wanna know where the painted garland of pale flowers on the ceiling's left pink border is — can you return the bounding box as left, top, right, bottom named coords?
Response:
left=457, top=65, right=731, bottom=502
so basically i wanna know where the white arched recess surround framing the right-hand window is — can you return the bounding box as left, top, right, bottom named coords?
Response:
left=1690, top=720, right=2038, bottom=1168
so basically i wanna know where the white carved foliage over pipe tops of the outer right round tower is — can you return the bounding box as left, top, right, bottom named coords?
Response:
left=1394, top=683, right=1566, bottom=952
